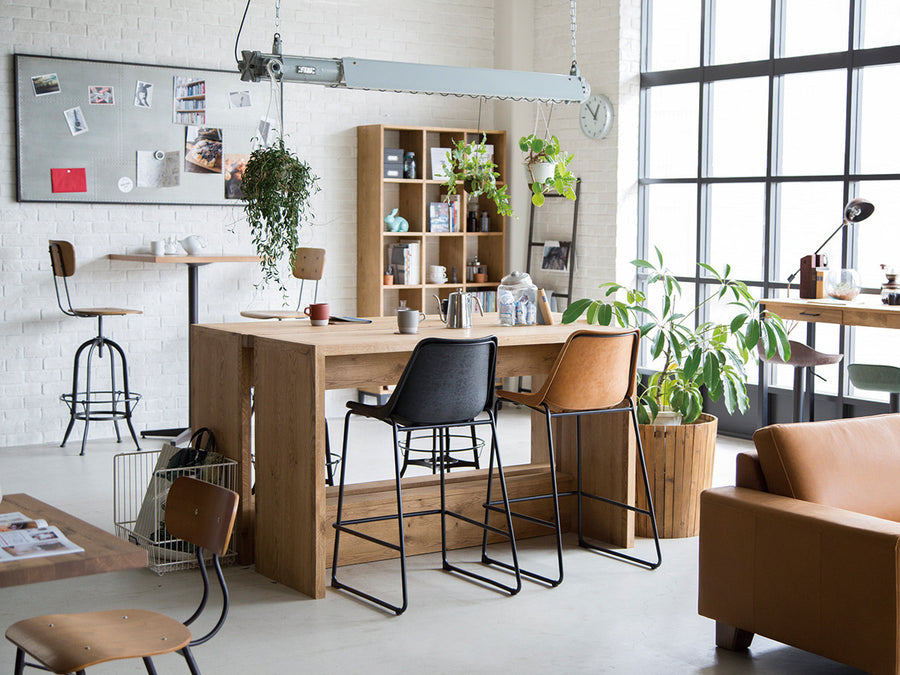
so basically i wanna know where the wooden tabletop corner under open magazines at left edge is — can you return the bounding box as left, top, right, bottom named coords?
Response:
left=0, top=494, right=147, bottom=588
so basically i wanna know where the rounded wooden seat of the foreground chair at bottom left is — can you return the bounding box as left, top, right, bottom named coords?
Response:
left=6, top=609, right=191, bottom=673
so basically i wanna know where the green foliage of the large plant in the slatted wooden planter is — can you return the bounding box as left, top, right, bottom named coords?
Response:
left=562, top=249, right=790, bottom=424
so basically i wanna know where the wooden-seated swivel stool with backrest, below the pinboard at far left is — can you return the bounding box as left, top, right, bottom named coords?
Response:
left=50, top=241, right=142, bottom=455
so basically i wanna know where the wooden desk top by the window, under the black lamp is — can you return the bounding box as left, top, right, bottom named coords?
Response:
left=762, top=295, right=900, bottom=328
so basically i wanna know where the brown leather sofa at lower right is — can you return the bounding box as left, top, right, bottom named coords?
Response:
left=699, top=415, right=900, bottom=673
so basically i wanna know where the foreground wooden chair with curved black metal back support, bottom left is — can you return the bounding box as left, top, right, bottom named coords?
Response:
left=6, top=476, right=238, bottom=675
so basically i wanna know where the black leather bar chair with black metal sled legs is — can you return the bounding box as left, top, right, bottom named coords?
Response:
left=331, top=336, right=522, bottom=614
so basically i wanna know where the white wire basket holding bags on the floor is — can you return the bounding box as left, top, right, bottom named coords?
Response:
left=113, top=450, right=237, bottom=574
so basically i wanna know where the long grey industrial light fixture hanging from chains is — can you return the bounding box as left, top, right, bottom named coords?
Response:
left=235, top=0, right=591, bottom=103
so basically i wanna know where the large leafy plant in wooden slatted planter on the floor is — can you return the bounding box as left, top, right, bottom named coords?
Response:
left=562, top=249, right=790, bottom=537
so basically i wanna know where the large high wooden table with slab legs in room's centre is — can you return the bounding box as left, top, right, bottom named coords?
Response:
left=191, top=314, right=635, bottom=598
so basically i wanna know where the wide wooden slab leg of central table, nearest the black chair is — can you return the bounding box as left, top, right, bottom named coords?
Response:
left=254, top=338, right=327, bottom=598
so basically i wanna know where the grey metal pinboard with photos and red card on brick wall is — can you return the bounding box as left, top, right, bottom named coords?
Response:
left=15, top=54, right=275, bottom=204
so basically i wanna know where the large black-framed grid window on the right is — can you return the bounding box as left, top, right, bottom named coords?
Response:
left=636, top=0, right=900, bottom=434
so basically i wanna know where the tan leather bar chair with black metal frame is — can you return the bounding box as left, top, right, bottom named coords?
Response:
left=482, top=329, right=662, bottom=586
